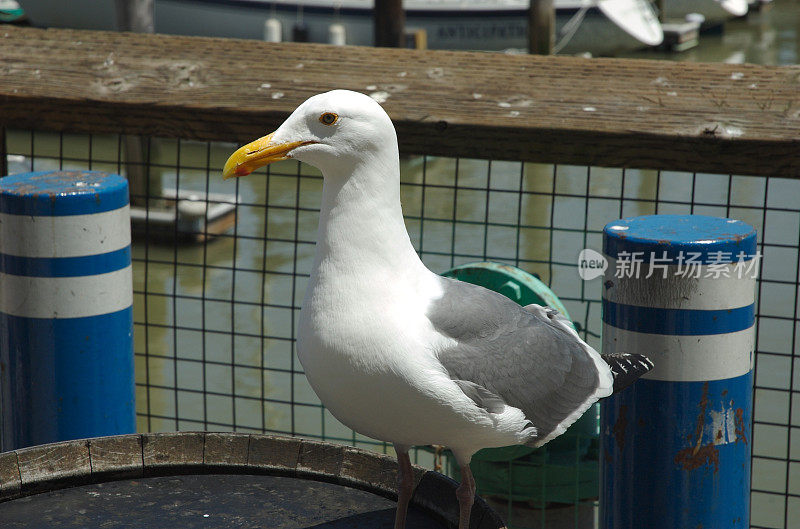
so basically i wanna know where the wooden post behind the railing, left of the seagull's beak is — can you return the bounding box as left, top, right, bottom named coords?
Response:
left=116, top=0, right=161, bottom=205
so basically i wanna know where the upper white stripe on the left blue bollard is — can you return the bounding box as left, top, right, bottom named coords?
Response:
left=0, top=206, right=131, bottom=257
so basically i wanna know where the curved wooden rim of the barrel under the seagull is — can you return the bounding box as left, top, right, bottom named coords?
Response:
left=0, top=432, right=505, bottom=529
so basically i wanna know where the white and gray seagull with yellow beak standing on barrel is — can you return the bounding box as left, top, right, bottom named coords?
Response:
left=223, top=90, right=653, bottom=529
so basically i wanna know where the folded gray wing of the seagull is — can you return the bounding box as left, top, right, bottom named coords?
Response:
left=427, top=278, right=610, bottom=446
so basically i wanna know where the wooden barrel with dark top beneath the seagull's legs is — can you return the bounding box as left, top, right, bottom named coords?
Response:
left=0, top=432, right=504, bottom=529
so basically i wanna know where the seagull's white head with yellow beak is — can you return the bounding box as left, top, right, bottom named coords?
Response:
left=223, top=90, right=397, bottom=178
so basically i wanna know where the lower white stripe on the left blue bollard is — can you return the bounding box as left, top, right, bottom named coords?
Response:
left=0, top=266, right=133, bottom=318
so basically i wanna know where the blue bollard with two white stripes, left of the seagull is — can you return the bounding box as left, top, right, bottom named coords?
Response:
left=0, top=171, right=136, bottom=450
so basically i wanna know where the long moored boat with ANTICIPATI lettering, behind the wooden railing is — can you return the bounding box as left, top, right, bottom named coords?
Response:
left=20, top=0, right=663, bottom=55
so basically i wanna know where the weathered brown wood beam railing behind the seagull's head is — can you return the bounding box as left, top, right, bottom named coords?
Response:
left=0, top=26, right=800, bottom=177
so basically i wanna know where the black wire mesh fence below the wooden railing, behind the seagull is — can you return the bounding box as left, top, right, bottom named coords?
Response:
left=6, top=126, right=800, bottom=529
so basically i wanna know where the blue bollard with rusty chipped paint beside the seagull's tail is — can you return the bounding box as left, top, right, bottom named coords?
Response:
left=600, top=215, right=758, bottom=529
